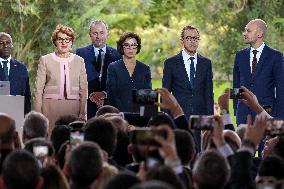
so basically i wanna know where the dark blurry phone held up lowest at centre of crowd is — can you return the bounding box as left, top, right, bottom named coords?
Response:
left=130, top=128, right=167, bottom=147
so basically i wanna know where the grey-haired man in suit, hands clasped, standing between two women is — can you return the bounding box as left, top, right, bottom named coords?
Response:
left=76, top=20, right=121, bottom=119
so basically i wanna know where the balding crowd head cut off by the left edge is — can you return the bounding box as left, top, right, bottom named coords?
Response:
left=0, top=113, right=16, bottom=144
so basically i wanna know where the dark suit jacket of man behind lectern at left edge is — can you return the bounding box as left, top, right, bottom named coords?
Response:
left=0, top=58, right=31, bottom=114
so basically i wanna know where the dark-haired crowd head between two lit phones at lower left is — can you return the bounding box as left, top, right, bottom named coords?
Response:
left=50, top=125, right=70, bottom=154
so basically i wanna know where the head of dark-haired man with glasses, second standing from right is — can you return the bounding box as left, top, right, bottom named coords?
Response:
left=180, top=25, right=200, bottom=55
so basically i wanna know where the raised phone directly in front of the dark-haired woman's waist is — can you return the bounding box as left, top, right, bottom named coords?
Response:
left=132, top=89, right=158, bottom=105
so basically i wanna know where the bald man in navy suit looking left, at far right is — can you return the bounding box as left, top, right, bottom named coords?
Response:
left=233, top=19, right=284, bottom=125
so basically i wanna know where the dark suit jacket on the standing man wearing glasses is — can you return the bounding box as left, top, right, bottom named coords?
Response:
left=163, top=52, right=214, bottom=118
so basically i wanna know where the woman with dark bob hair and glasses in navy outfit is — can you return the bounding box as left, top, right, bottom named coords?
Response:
left=107, top=32, right=152, bottom=112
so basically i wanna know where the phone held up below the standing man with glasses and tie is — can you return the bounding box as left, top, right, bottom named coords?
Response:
left=189, top=115, right=214, bottom=130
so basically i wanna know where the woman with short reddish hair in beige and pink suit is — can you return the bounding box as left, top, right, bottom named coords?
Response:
left=34, top=25, right=87, bottom=136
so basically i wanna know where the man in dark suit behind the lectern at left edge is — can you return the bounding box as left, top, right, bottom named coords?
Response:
left=0, top=32, right=31, bottom=114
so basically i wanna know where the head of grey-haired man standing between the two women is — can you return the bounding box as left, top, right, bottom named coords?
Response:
left=89, top=20, right=109, bottom=48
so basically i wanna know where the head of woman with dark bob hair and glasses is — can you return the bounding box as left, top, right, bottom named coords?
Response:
left=116, top=32, right=141, bottom=57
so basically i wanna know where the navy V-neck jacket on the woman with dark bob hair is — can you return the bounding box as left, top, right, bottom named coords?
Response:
left=107, top=59, right=152, bottom=112
